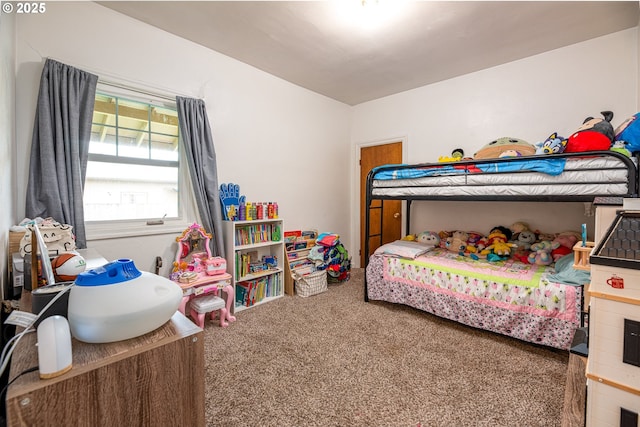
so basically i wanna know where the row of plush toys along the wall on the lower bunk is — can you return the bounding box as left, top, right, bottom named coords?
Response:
left=404, top=222, right=580, bottom=265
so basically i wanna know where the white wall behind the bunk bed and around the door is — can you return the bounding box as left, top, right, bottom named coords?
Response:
left=351, top=28, right=638, bottom=264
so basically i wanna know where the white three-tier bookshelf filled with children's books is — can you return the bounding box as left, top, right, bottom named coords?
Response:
left=224, top=219, right=285, bottom=312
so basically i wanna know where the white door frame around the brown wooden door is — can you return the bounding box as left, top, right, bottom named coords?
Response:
left=350, top=135, right=409, bottom=268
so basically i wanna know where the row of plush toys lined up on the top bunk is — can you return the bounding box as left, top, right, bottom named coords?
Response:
left=438, top=111, right=640, bottom=162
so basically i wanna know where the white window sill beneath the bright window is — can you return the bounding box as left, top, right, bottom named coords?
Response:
left=85, top=220, right=192, bottom=242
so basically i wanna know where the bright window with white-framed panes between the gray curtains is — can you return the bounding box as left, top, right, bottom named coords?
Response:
left=84, top=92, right=180, bottom=222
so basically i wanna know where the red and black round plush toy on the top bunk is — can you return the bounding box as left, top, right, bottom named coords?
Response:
left=564, top=111, right=615, bottom=153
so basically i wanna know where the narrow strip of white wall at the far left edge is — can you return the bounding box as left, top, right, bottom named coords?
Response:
left=0, top=12, right=16, bottom=296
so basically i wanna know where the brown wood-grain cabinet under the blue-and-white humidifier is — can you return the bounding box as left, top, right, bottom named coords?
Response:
left=6, top=296, right=205, bottom=427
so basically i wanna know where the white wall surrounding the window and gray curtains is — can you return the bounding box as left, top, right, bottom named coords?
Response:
left=16, top=2, right=351, bottom=270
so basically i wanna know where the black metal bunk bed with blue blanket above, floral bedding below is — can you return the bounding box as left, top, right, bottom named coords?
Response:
left=364, top=151, right=639, bottom=349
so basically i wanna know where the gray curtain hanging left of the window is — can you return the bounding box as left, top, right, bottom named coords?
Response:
left=25, top=59, right=98, bottom=248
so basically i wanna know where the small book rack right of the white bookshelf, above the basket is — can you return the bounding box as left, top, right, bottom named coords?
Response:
left=284, top=230, right=318, bottom=295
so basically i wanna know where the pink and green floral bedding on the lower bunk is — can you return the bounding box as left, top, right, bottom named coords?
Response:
left=366, top=248, right=582, bottom=349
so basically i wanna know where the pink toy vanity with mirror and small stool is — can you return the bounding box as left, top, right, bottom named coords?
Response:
left=171, top=223, right=236, bottom=327
